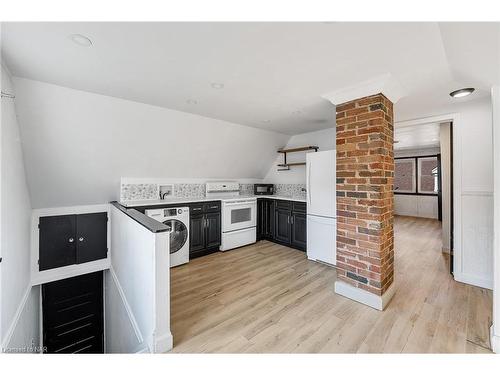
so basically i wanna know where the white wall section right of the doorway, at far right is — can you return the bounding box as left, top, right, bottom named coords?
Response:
left=453, top=98, right=493, bottom=289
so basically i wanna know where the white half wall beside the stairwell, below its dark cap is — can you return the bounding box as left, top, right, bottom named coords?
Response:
left=105, top=206, right=172, bottom=353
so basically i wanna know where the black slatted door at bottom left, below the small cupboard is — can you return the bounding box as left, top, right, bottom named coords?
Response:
left=42, top=271, right=104, bottom=353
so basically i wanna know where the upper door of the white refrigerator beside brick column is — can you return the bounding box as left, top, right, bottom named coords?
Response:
left=306, top=150, right=336, bottom=217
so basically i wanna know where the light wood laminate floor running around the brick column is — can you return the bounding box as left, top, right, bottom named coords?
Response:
left=171, top=217, right=492, bottom=353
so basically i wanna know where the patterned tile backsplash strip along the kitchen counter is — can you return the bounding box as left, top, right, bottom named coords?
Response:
left=120, top=183, right=306, bottom=202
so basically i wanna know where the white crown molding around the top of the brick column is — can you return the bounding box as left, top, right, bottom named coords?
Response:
left=321, top=73, right=405, bottom=105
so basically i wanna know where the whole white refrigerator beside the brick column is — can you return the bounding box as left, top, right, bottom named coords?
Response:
left=306, top=150, right=337, bottom=266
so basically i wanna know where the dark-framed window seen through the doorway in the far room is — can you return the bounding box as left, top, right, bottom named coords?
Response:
left=394, top=155, right=440, bottom=195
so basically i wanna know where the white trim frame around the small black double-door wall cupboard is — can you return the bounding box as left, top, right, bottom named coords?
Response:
left=30, top=204, right=111, bottom=285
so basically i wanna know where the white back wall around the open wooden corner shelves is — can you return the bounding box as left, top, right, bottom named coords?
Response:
left=264, top=127, right=336, bottom=184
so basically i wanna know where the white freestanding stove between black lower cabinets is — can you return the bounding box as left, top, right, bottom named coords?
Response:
left=206, top=181, right=257, bottom=251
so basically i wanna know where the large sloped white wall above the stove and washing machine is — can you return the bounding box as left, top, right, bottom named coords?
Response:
left=14, top=78, right=290, bottom=208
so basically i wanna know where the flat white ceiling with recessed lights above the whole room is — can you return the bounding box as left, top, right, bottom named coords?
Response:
left=2, top=22, right=499, bottom=134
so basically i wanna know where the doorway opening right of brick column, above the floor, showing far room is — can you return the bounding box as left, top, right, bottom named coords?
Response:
left=394, top=121, right=453, bottom=274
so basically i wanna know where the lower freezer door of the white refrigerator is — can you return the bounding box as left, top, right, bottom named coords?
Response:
left=307, top=215, right=337, bottom=265
